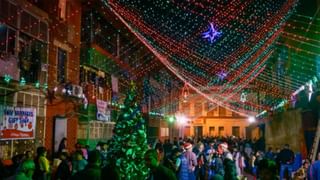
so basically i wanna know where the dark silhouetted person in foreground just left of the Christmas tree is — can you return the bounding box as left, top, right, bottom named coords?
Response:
left=71, top=150, right=101, bottom=180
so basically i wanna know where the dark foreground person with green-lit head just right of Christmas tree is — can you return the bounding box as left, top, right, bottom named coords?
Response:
left=144, top=149, right=177, bottom=180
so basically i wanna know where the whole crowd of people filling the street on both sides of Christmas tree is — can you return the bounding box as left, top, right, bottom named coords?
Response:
left=0, top=137, right=320, bottom=180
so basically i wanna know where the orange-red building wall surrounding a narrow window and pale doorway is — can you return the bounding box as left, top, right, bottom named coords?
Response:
left=43, top=0, right=81, bottom=154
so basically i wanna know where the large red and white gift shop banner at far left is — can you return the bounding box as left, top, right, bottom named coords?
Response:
left=0, top=106, right=36, bottom=139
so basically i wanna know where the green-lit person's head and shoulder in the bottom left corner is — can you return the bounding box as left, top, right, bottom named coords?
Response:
left=6, top=160, right=35, bottom=180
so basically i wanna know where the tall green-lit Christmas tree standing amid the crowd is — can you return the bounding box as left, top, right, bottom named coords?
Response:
left=108, top=83, right=148, bottom=179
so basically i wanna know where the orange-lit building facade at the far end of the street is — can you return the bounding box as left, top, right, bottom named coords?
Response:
left=174, top=94, right=250, bottom=138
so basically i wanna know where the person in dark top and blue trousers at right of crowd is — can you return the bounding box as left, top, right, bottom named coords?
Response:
left=278, top=144, right=294, bottom=180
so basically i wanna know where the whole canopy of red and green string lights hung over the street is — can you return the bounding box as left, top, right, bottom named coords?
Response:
left=105, top=0, right=319, bottom=115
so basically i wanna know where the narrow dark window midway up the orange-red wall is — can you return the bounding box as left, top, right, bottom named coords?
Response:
left=57, top=48, right=67, bottom=83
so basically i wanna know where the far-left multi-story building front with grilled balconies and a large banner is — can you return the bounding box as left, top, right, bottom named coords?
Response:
left=0, top=0, right=49, bottom=159
